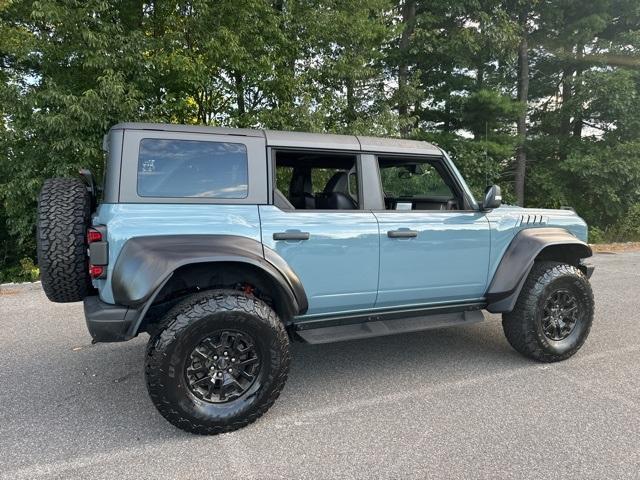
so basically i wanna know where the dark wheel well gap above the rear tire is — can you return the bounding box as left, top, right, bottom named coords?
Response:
left=140, top=262, right=297, bottom=331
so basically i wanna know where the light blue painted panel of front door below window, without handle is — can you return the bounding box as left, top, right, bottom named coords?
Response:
left=375, top=211, right=490, bottom=307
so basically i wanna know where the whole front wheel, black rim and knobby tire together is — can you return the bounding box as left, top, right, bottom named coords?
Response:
left=502, top=262, right=594, bottom=362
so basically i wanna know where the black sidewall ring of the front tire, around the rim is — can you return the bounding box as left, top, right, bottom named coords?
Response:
left=533, top=274, right=593, bottom=356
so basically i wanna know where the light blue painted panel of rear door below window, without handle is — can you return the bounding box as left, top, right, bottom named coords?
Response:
left=260, top=205, right=379, bottom=315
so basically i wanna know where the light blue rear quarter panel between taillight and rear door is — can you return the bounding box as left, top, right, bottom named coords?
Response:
left=93, top=203, right=260, bottom=303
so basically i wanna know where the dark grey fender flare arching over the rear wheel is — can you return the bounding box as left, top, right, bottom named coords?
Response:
left=111, top=235, right=308, bottom=322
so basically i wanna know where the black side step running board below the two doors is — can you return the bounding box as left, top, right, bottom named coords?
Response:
left=296, top=310, right=484, bottom=343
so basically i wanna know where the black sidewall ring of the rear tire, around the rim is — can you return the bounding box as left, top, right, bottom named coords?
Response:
left=150, top=304, right=285, bottom=427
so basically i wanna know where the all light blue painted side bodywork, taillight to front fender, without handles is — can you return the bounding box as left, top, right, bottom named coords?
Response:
left=94, top=204, right=587, bottom=317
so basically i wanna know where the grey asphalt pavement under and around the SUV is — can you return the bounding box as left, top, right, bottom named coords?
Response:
left=0, top=253, right=640, bottom=480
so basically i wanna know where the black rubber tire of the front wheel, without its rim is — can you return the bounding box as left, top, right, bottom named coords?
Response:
left=502, top=261, right=594, bottom=362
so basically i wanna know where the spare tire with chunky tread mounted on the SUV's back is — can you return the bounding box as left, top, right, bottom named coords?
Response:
left=36, top=178, right=92, bottom=303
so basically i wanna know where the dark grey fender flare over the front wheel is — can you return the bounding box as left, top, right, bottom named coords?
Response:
left=485, top=228, right=593, bottom=313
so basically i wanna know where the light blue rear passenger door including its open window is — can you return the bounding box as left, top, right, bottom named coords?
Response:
left=260, top=149, right=379, bottom=316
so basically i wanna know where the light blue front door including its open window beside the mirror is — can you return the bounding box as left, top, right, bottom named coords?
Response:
left=375, top=157, right=490, bottom=307
